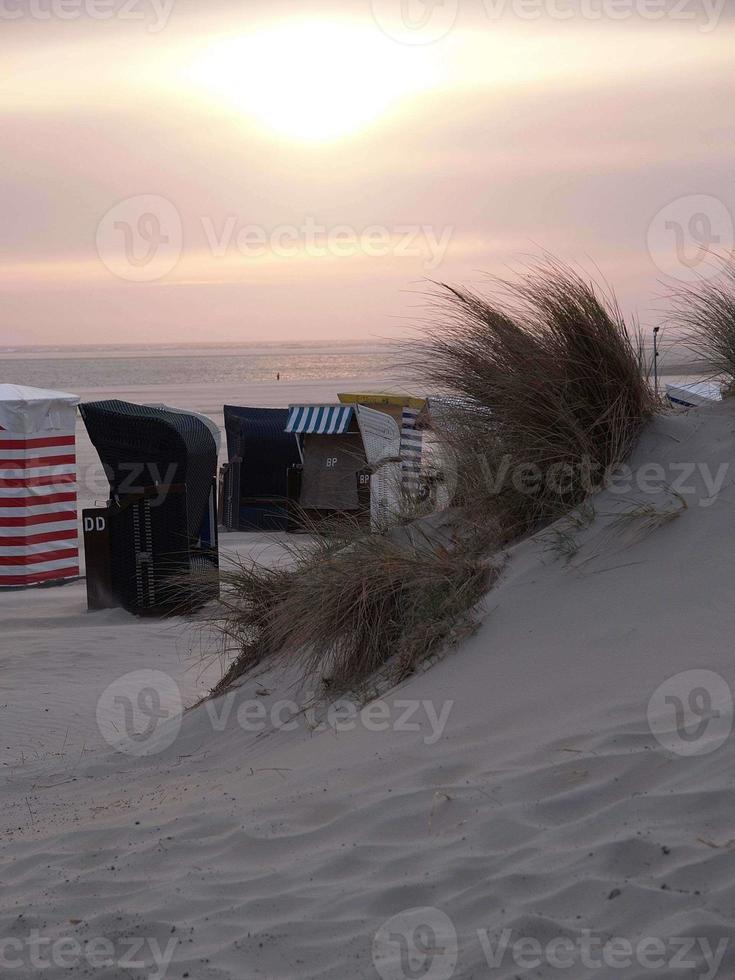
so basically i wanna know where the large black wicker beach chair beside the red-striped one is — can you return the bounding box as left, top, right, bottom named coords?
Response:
left=80, top=401, right=218, bottom=613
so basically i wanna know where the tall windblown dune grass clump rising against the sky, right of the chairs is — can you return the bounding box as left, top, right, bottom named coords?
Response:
left=410, top=260, right=656, bottom=540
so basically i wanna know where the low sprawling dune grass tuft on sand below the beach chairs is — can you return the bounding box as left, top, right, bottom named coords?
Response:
left=213, top=528, right=498, bottom=694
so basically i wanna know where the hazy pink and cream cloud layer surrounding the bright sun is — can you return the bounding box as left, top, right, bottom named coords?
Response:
left=0, top=7, right=735, bottom=343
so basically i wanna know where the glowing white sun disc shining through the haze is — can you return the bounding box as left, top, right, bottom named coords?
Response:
left=189, top=22, right=432, bottom=140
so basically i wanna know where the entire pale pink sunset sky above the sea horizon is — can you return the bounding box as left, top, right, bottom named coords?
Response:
left=0, top=0, right=735, bottom=346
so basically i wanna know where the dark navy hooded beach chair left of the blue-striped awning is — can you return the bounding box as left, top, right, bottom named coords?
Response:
left=222, top=405, right=300, bottom=531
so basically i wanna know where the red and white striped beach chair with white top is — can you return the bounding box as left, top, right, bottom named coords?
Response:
left=0, top=384, right=79, bottom=588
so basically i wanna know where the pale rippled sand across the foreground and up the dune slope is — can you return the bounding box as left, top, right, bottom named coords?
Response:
left=0, top=394, right=735, bottom=980
